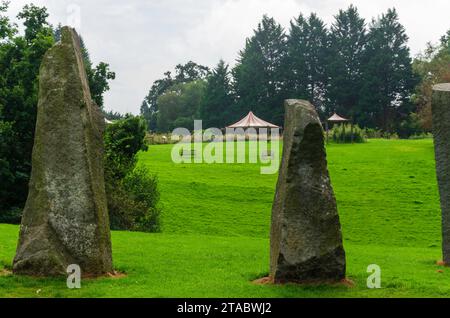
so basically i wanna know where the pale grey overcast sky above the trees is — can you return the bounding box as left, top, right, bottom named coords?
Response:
left=4, top=0, right=450, bottom=114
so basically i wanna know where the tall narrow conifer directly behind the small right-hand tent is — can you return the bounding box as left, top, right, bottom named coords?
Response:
left=327, top=5, right=366, bottom=117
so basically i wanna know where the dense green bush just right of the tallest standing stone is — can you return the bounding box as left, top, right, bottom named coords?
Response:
left=105, top=115, right=161, bottom=232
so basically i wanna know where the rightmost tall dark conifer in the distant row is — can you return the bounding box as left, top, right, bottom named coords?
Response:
left=358, top=9, right=416, bottom=132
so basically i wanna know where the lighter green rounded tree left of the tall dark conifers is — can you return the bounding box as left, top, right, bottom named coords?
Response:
left=157, top=80, right=206, bottom=132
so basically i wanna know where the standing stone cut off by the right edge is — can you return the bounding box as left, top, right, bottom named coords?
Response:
left=431, top=83, right=450, bottom=265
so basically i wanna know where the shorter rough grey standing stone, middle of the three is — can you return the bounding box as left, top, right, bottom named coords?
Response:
left=270, top=100, right=346, bottom=283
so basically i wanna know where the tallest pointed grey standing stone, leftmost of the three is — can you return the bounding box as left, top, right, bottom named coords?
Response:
left=13, top=27, right=113, bottom=276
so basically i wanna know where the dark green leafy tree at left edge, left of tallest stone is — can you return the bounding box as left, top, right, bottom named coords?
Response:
left=0, top=2, right=53, bottom=214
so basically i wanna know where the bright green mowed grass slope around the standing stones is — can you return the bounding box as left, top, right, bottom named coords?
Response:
left=0, top=140, right=450, bottom=297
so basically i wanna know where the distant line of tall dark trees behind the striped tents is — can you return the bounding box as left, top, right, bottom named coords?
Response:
left=141, top=6, right=440, bottom=137
